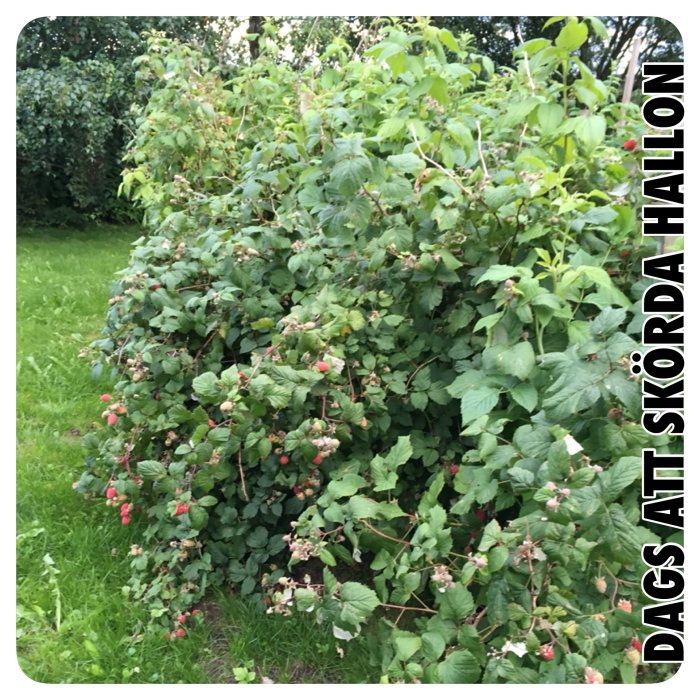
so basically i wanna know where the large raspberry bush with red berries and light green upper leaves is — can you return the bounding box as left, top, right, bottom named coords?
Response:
left=77, top=19, right=678, bottom=683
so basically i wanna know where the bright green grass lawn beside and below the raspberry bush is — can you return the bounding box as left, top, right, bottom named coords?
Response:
left=16, top=227, right=376, bottom=683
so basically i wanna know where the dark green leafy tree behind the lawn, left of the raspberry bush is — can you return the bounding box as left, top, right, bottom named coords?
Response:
left=17, top=17, right=238, bottom=224
